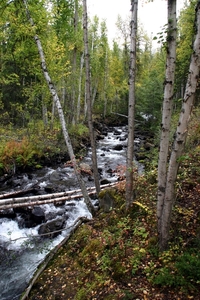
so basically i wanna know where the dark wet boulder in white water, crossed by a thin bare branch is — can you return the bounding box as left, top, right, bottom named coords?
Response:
left=38, top=218, right=65, bottom=238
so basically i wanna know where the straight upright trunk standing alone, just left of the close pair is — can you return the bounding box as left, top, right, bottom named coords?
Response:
left=126, top=0, right=138, bottom=209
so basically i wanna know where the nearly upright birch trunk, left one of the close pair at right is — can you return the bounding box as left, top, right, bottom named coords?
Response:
left=157, top=0, right=177, bottom=244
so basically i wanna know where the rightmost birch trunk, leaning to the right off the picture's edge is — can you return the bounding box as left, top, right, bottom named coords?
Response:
left=160, top=0, right=200, bottom=250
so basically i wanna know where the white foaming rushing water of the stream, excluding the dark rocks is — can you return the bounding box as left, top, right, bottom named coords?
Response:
left=0, top=127, right=144, bottom=300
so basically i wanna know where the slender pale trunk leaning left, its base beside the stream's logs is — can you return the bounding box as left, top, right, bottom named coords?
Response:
left=23, top=0, right=95, bottom=215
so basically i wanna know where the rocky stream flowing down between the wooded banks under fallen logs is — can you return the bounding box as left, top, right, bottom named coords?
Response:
left=0, top=126, right=143, bottom=300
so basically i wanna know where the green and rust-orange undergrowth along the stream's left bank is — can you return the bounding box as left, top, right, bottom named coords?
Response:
left=0, top=123, right=88, bottom=175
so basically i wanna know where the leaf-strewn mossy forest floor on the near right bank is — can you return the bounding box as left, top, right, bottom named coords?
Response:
left=25, top=141, right=200, bottom=300
